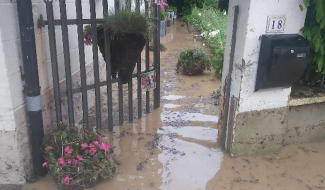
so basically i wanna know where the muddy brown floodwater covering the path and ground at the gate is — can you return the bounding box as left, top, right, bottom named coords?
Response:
left=23, top=21, right=325, bottom=190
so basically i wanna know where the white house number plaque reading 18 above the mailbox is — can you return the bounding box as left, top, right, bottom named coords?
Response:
left=266, top=16, right=286, bottom=33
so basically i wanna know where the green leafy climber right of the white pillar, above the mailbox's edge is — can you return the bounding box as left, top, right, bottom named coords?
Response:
left=300, top=0, right=325, bottom=75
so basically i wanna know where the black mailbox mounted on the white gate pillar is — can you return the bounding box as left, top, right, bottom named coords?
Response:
left=255, top=34, right=310, bottom=91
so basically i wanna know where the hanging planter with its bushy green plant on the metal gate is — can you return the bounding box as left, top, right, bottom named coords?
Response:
left=84, top=10, right=149, bottom=84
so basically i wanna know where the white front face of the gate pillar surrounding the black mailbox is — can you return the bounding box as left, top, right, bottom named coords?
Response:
left=239, top=0, right=306, bottom=112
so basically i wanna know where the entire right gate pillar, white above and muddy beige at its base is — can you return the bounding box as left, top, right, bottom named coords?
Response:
left=222, top=0, right=306, bottom=155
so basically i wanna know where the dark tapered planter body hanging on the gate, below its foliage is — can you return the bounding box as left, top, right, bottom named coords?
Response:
left=97, top=27, right=146, bottom=84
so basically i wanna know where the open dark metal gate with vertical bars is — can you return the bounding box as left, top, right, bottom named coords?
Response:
left=39, top=0, right=160, bottom=130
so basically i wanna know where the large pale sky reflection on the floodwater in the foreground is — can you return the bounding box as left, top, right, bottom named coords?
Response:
left=158, top=135, right=223, bottom=190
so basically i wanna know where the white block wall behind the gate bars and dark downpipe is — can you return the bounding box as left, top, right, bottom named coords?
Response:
left=0, top=0, right=119, bottom=184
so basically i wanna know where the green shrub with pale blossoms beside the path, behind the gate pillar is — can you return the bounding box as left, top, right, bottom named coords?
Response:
left=184, top=6, right=227, bottom=76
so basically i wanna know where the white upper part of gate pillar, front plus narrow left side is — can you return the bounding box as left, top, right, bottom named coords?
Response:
left=222, top=0, right=306, bottom=112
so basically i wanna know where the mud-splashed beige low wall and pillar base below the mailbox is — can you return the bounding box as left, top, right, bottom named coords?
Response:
left=231, top=93, right=325, bottom=156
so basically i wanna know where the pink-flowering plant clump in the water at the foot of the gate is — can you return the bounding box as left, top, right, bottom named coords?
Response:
left=43, top=126, right=116, bottom=187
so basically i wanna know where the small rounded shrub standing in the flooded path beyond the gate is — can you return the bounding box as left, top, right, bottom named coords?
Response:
left=176, top=49, right=211, bottom=75
